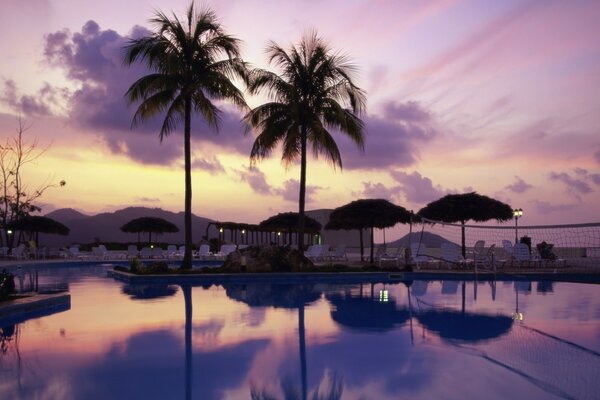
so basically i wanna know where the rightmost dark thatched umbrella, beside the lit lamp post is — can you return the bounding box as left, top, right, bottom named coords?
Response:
left=417, top=192, right=513, bottom=257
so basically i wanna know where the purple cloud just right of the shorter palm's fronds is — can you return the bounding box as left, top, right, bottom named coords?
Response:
left=336, top=101, right=441, bottom=169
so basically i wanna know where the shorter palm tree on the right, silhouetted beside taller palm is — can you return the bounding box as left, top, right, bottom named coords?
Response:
left=244, top=32, right=366, bottom=249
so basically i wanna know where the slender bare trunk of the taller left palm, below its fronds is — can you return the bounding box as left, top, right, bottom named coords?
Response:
left=181, top=97, right=192, bottom=269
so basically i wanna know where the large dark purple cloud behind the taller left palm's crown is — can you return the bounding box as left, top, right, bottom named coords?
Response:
left=44, top=20, right=252, bottom=164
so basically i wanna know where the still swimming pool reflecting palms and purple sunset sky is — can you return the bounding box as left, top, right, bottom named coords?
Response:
left=0, top=265, right=600, bottom=399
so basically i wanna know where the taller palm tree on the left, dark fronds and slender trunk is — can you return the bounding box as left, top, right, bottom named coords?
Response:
left=125, top=2, right=246, bottom=269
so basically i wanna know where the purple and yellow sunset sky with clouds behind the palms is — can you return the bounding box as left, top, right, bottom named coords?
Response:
left=0, top=0, right=600, bottom=241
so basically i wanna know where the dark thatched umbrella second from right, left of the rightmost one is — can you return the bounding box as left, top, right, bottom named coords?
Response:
left=325, top=199, right=411, bottom=262
